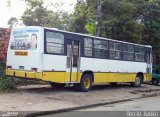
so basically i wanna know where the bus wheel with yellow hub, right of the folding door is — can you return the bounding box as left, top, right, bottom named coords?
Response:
left=79, top=74, right=93, bottom=92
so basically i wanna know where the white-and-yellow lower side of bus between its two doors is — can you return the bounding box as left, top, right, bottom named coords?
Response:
left=78, top=57, right=150, bottom=83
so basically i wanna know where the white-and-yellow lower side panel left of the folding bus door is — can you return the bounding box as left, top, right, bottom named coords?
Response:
left=42, top=54, right=67, bottom=83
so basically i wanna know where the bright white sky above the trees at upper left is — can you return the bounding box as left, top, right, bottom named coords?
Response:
left=0, top=0, right=77, bottom=28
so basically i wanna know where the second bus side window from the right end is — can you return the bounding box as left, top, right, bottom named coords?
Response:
left=123, top=45, right=134, bottom=61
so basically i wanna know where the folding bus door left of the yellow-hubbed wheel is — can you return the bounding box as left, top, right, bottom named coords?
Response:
left=66, top=40, right=80, bottom=82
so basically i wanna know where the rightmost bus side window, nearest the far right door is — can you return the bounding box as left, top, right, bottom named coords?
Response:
left=135, top=47, right=144, bottom=61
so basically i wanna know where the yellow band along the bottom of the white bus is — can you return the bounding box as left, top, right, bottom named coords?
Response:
left=6, top=69, right=152, bottom=83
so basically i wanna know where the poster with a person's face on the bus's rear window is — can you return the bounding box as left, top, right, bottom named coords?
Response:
left=10, top=29, right=39, bottom=50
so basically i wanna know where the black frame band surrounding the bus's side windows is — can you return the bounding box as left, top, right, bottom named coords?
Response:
left=43, top=29, right=152, bottom=63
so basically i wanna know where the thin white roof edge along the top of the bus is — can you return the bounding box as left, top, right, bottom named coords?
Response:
left=16, top=26, right=152, bottom=48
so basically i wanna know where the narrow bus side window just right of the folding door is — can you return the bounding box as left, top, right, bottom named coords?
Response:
left=84, top=38, right=92, bottom=57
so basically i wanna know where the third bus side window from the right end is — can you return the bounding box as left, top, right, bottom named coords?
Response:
left=109, top=42, right=122, bottom=59
